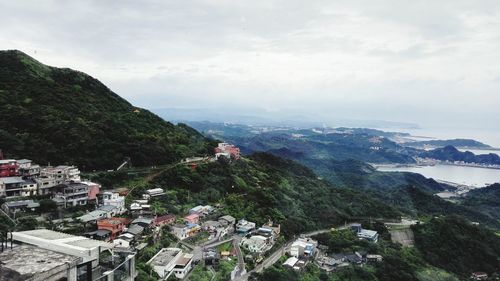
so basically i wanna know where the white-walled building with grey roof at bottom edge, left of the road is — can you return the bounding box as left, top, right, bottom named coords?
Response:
left=147, top=248, right=193, bottom=280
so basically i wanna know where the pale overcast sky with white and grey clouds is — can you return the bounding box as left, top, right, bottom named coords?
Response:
left=0, top=0, right=500, bottom=129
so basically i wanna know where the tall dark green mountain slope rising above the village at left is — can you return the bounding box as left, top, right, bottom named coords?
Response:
left=0, top=51, right=211, bottom=170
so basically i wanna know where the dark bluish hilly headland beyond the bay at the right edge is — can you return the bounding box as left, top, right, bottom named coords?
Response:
left=419, top=145, right=500, bottom=165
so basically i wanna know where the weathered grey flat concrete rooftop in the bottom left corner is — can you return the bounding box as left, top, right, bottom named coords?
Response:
left=0, top=244, right=81, bottom=280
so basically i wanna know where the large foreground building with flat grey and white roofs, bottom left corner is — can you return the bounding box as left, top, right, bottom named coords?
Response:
left=0, top=229, right=137, bottom=281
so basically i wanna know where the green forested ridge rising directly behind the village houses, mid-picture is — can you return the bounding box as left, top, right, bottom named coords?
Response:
left=146, top=153, right=399, bottom=234
